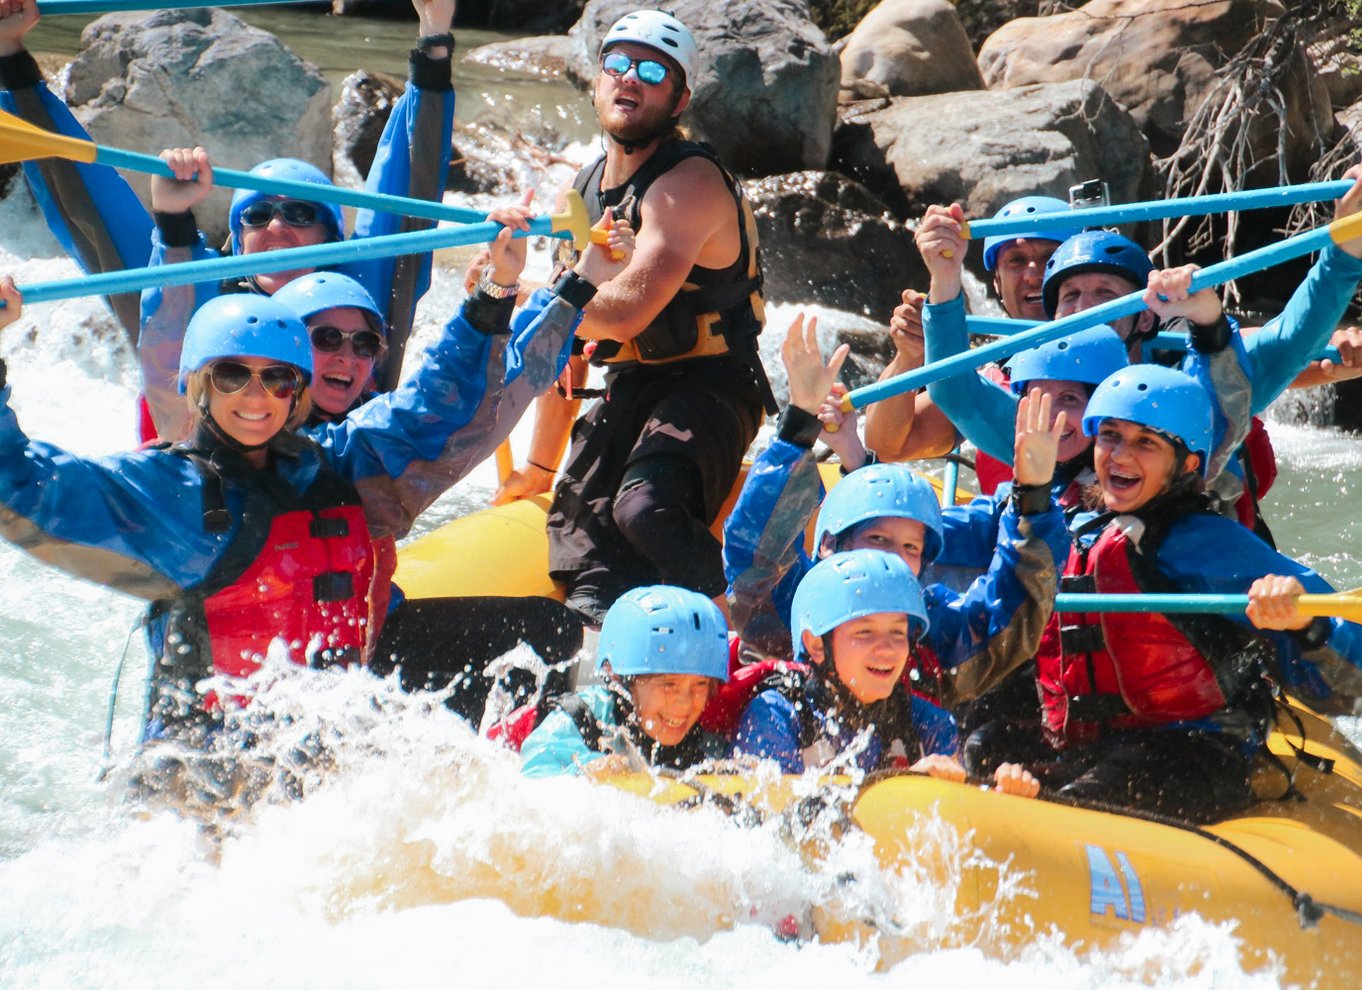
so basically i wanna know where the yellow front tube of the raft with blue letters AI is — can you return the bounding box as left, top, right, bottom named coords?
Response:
left=610, top=708, right=1362, bottom=990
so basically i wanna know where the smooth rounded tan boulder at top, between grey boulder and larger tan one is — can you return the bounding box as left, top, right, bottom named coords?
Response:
left=839, top=0, right=983, bottom=99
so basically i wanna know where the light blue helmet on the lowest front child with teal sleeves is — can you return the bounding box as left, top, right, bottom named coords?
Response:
left=597, top=584, right=729, bottom=681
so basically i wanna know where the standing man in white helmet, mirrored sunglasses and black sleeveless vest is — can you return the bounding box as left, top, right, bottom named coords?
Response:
left=497, top=11, right=775, bottom=624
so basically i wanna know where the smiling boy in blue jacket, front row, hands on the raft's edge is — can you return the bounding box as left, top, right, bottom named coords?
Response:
left=734, top=550, right=1039, bottom=795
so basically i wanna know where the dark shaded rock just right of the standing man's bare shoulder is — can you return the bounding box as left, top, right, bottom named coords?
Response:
left=744, top=172, right=928, bottom=323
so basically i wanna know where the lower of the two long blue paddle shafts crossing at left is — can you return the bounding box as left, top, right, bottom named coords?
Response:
left=22, top=217, right=558, bottom=302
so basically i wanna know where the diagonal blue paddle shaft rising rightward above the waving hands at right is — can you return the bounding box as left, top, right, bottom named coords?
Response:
left=843, top=226, right=1332, bottom=409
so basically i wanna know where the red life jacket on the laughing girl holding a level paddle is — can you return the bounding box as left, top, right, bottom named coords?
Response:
left=1036, top=524, right=1227, bottom=744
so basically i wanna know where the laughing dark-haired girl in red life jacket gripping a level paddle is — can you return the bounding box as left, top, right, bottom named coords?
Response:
left=966, top=365, right=1362, bottom=821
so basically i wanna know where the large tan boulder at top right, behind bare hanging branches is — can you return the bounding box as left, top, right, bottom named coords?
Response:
left=979, top=0, right=1329, bottom=173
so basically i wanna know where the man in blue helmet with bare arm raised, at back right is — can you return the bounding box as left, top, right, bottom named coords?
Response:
left=865, top=196, right=1079, bottom=465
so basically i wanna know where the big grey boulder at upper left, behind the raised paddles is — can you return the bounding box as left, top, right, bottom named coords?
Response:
left=65, top=8, right=331, bottom=240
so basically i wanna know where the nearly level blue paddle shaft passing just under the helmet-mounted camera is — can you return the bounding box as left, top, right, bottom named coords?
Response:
left=970, top=178, right=1352, bottom=238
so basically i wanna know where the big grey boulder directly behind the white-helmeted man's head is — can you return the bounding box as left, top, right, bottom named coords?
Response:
left=568, top=0, right=842, bottom=176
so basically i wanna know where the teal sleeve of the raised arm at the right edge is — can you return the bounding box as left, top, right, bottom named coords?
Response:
left=1245, top=244, right=1362, bottom=414
